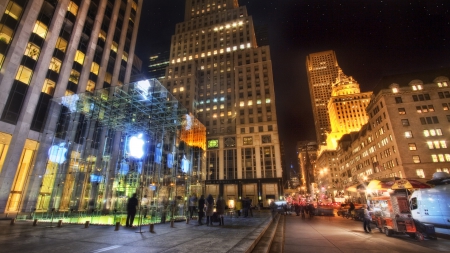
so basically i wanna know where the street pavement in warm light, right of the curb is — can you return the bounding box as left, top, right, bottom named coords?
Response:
left=284, top=215, right=450, bottom=253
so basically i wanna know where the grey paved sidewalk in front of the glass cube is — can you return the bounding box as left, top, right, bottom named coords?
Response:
left=0, top=211, right=271, bottom=253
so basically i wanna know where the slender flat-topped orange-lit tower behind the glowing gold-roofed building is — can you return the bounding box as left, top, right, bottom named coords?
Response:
left=306, top=50, right=339, bottom=145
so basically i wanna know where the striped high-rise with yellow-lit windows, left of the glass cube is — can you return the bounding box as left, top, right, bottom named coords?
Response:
left=0, top=0, right=142, bottom=213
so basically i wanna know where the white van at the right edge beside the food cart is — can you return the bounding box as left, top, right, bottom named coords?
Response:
left=409, top=173, right=450, bottom=229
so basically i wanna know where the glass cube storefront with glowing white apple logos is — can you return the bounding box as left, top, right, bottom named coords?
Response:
left=35, top=79, right=206, bottom=224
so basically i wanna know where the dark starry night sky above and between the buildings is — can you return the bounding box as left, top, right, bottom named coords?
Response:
left=136, top=0, right=450, bottom=172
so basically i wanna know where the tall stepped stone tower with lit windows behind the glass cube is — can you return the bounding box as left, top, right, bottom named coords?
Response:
left=163, top=0, right=282, bottom=206
